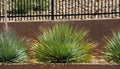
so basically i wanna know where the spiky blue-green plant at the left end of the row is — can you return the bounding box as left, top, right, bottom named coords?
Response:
left=0, top=31, right=27, bottom=63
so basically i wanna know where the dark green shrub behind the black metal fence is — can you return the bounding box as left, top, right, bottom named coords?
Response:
left=11, top=0, right=48, bottom=14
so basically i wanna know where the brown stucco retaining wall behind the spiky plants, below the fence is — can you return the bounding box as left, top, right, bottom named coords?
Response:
left=0, top=19, right=120, bottom=55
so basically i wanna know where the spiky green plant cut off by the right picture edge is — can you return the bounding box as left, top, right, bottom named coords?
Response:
left=105, top=32, right=120, bottom=63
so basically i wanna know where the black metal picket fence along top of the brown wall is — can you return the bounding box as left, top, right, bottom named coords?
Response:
left=0, top=0, right=120, bottom=21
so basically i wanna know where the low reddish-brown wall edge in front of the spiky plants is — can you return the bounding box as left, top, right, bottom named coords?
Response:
left=0, top=64, right=120, bottom=69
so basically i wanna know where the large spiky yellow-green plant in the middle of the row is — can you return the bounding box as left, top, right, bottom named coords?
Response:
left=34, top=24, right=91, bottom=63
